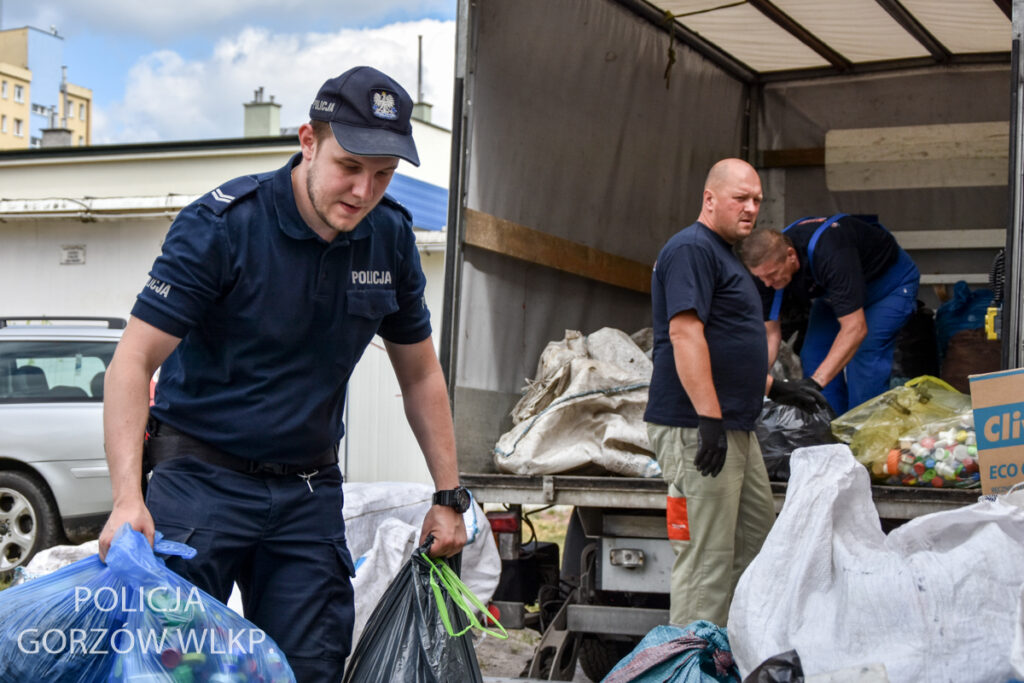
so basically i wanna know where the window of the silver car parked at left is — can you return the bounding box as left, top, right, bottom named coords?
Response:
left=0, top=340, right=117, bottom=403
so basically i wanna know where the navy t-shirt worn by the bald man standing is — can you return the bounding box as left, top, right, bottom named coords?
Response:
left=644, top=223, right=768, bottom=431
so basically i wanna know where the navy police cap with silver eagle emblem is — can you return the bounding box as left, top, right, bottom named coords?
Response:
left=309, top=67, right=420, bottom=166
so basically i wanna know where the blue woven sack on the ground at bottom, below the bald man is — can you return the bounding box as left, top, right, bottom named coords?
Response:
left=603, top=621, right=740, bottom=683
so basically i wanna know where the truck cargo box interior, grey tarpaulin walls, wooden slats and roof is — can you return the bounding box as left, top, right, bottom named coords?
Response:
left=448, top=0, right=1024, bottom=471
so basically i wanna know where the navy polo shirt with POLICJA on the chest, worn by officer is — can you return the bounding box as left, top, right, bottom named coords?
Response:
left=132, top=155, right=430, bottom=464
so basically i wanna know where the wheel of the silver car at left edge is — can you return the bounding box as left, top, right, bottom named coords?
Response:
left=0, top=471, right=61, bottom=572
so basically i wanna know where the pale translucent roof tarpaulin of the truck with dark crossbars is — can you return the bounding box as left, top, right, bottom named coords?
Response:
left=643, top=0, right=1011, bottom=79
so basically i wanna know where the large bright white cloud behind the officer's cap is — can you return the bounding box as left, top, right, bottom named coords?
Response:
left=93, top=19, right=455, bottom=144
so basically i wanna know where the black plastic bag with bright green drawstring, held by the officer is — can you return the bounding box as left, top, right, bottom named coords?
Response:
left=342, top=538, right=483, bottom=683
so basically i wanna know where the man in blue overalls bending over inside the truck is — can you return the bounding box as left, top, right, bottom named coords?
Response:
left=736, top=214, right=921, bottom=415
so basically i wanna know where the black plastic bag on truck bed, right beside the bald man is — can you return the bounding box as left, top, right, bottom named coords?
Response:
left=755, top=400, right=836, bottom=481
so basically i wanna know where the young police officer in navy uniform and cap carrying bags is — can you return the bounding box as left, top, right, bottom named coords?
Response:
left=100, top=67, right=468, bottom=681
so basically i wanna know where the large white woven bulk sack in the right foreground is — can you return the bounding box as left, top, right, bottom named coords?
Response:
left=728, top=444, right=1024, bottom=683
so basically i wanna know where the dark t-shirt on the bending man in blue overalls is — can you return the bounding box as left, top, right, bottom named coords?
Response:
left=755, top=216, right=899, bottom=321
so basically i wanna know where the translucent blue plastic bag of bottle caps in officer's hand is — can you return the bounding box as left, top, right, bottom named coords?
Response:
left=0, top=524, right=295, bottom=683
